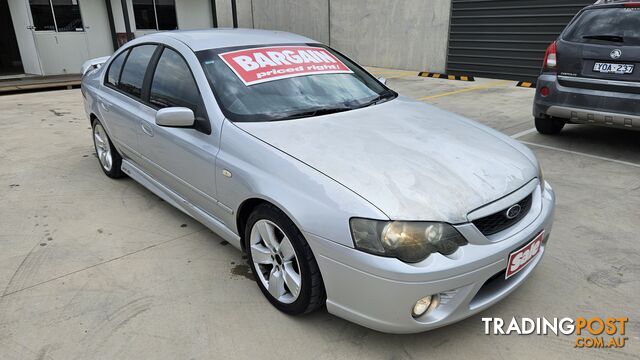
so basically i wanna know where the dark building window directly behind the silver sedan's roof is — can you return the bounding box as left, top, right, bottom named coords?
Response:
left=133, top=0, right=178, bottom=30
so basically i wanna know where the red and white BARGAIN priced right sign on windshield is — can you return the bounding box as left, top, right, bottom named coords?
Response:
left=219, top=46, right=353, bottom=86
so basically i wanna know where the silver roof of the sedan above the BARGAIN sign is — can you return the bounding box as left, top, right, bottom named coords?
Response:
left=138, top=28, right=318, bottom=51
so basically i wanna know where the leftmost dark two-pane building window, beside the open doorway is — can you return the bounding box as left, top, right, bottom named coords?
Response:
left=29, top=0, right=84, bottom=32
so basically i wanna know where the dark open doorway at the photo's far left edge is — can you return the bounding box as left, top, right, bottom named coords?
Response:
left=0, top=0, right=24, bottom=76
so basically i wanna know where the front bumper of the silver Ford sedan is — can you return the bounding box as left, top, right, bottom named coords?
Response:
left=305, top=184, right=555, bottom=333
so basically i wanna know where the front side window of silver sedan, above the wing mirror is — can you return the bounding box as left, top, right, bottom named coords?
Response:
left=149, top=48, right=202, bottom=115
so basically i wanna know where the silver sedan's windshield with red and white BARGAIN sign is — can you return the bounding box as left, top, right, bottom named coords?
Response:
left=196, top=44, right=397, bottom=122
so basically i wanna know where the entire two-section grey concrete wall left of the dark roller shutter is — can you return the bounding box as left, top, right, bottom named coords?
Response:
left=248, top=0, right=451, bottom=72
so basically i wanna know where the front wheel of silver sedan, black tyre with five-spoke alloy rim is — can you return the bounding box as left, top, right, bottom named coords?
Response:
left=245, top=204, right=326, bottom=315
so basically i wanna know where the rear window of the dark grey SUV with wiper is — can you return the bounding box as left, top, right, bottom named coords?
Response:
left=563, top=8, right=640, bottom=45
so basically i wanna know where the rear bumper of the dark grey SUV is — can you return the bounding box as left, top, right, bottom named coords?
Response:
left=533, top=74, right=640, bottom=130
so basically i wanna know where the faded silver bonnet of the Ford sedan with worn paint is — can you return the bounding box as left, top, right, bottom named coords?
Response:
left=235, top=98, right=537, bottom=223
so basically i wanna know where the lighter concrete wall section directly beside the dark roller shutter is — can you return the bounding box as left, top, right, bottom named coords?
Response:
left=330, top=0, right=451, bottom=72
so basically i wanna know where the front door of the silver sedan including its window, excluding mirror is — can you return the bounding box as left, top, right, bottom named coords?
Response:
left=139, top=48, right=220, bottom=218
